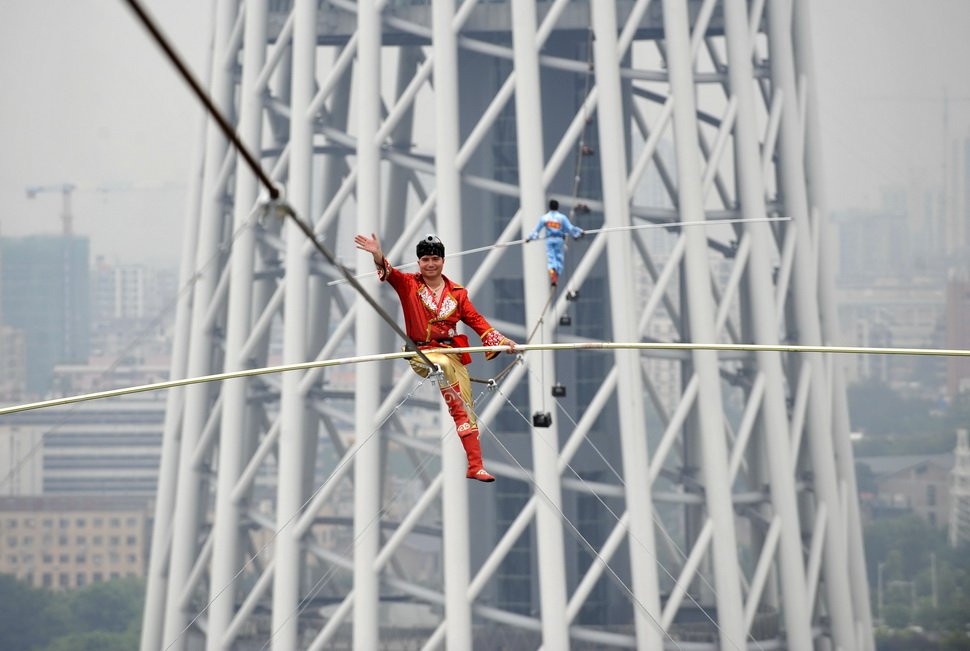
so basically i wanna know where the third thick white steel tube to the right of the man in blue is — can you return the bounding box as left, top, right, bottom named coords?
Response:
left=724, top=0, right=813, bottom=651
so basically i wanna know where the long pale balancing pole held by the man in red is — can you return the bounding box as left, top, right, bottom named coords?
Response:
left=0, top=341, right=970, bottom=416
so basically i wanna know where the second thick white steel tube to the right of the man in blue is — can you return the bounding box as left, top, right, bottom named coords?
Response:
left=663, top=0, right=745, bottom=649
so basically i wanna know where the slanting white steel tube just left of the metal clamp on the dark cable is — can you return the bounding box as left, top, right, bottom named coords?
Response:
left=206, top=0, right=268, bottom=651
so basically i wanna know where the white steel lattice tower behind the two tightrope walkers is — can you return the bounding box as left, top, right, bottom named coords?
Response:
left=142, top=0, right=873, bottom=651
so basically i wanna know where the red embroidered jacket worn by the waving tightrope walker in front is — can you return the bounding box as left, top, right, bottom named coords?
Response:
left=377, top=258, right=505, bottom=364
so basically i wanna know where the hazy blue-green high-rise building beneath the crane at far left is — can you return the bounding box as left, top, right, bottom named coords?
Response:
left=0, top=235, right=90, bottom=396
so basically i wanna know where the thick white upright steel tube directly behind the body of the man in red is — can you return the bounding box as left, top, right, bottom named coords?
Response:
left=431, top=0, right=472, bottom=649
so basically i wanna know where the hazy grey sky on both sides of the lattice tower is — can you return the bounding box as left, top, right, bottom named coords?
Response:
left=0, top=0, right=970, bottom=266
